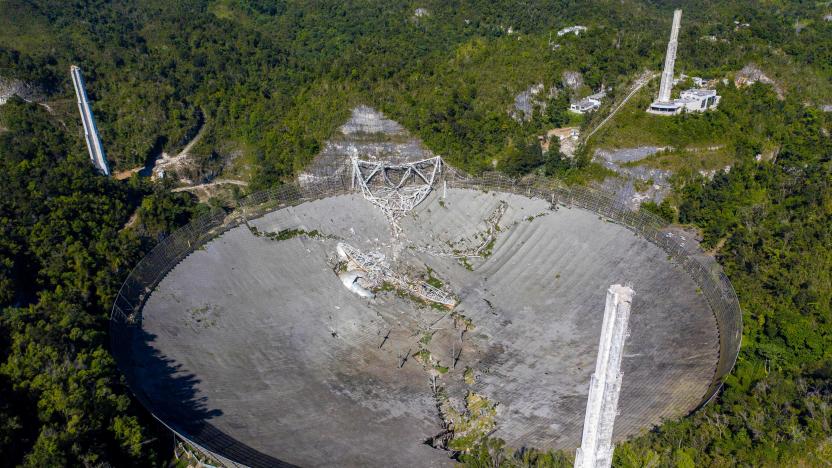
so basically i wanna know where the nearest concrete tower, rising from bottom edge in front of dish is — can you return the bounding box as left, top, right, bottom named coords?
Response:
left=575, top=284, right=634, bottom=468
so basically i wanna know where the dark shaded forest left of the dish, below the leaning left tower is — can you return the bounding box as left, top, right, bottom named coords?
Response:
left=0, top=99, right=200, bottom=466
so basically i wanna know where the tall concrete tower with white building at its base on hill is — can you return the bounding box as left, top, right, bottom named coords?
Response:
left=647, top=10, right=720, bottom=115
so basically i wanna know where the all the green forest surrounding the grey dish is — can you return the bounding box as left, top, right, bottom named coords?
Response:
left=0, top=0, right=832, bottom=467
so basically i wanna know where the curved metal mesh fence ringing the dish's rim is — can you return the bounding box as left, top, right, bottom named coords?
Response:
left=110, top=173, right=742, bottom=466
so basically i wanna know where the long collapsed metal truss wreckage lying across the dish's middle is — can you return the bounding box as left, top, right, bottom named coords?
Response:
left=336, top=242, right=456, bottom=308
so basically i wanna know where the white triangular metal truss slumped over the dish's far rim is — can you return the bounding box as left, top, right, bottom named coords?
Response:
left=352, top=156, right=442, bottom=232
